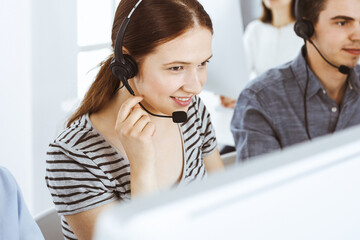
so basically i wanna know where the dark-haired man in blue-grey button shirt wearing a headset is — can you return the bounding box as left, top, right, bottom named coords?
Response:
left=231, top=0, right=360, bottom=162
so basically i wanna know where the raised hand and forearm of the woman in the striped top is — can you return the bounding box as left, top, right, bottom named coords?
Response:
left=115, top=96, right=157, bottom=195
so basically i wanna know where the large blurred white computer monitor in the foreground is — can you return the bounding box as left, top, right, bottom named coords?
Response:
left=95, top=126, right=360, bottom=240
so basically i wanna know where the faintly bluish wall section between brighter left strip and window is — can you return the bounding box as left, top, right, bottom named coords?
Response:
left=31, top=0, right=77, bottom=216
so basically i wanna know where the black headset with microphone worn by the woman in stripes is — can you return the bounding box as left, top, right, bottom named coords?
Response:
left=110, top=0, right=187, bottom=123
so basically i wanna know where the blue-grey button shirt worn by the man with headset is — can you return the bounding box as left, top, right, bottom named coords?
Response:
left=231, top=49, right=360, bottom=162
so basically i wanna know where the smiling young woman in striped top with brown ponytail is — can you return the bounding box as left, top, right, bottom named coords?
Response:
left=46, top=0, right=223, bottom=239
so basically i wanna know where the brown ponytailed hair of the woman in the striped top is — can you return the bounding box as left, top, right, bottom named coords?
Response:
left=67, top=0, right=213, bottom=127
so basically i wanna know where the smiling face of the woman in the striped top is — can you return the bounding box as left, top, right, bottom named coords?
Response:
left=132, top=27, right=212, bottom=115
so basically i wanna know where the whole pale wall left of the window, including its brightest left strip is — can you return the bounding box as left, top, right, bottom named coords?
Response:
left=0, top=0, right=77, bottom=215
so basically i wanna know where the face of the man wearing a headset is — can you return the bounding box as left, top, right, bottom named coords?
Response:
left=312, top=0, right=360, bottom=67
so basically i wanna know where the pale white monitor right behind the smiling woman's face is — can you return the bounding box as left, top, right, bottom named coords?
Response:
left=199, top=0, right=249, bottom=98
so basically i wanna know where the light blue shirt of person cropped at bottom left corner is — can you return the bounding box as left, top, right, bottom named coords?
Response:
left=0, top=167, right=44, bottom=240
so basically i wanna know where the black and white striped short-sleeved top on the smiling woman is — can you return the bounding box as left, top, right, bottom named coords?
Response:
left=45, top=97, right=217, bottom=239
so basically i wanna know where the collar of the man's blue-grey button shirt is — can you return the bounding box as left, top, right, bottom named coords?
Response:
left=291, top=46, right=360, bottom=99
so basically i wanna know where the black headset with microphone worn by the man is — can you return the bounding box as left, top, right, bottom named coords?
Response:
left=294, top=0, right=350, bottom=140
